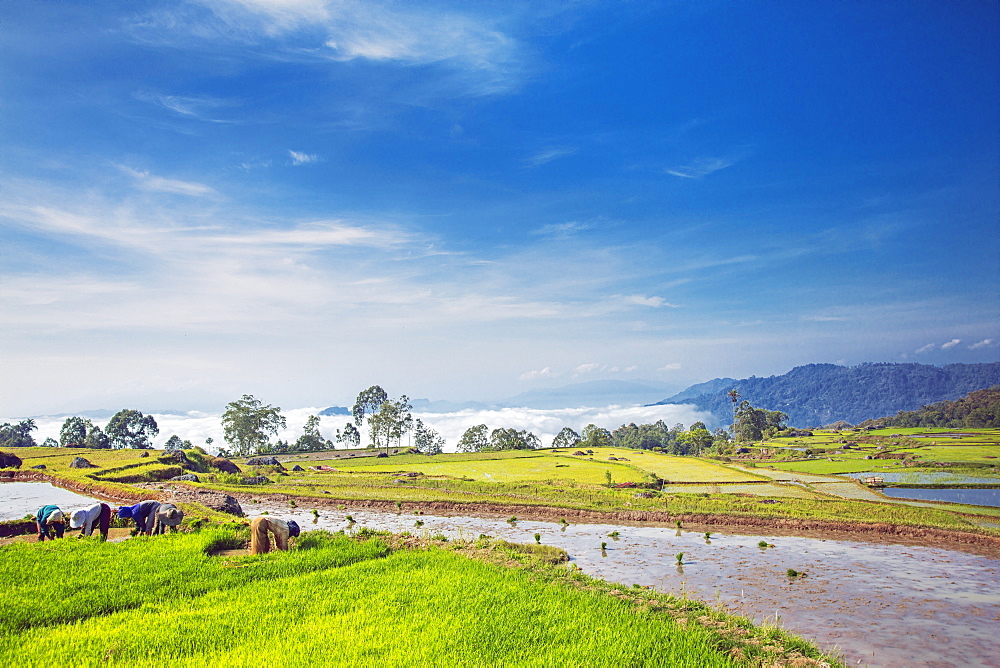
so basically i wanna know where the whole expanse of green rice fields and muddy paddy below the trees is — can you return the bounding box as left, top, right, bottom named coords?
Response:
left=0, top=404, right=1000, bottom=666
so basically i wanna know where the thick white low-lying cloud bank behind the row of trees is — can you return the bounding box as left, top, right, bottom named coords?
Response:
left=19, top=405, right=710, bottom=452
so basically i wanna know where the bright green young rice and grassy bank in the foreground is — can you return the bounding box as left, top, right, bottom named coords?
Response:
left=0, top=527, right=836, bottom=667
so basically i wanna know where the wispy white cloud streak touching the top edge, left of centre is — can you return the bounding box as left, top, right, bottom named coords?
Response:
left=162, top=0, right=524, bottom=95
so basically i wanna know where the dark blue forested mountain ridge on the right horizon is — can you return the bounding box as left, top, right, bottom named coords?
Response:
left=655, top=362, right=1000, bottom=427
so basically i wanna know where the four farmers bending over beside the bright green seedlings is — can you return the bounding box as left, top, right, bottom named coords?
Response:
left=35, top=500, right=299, bottom=554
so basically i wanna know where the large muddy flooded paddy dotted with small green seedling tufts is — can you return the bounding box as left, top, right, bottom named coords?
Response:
left=243, top=503, right=1000, bottom=667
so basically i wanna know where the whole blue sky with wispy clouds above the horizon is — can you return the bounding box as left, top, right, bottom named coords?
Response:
left=0, top=0, right=1000, bottom=416
